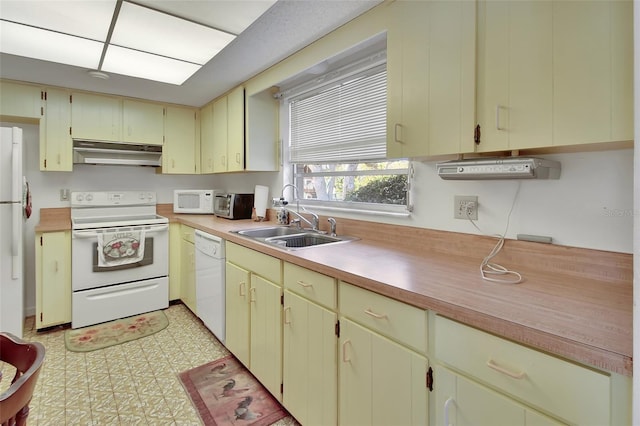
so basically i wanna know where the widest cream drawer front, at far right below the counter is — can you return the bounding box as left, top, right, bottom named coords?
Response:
left=435, top=316, right=611, bottom=425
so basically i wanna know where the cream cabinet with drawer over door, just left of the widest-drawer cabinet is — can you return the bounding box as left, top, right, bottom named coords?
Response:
left=338, top=282, right=431, bottom=425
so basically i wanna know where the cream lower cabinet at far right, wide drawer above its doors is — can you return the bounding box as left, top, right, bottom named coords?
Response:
left=434, top=315, right=631, bottom=426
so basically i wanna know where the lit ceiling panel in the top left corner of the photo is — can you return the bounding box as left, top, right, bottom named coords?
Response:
left=0, top=0, right=116, bottom=41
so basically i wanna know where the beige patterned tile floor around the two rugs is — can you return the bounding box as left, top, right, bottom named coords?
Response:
left=3, top=304, right=296, bottom=426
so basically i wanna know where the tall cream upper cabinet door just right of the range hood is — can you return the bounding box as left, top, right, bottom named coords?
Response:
left=162, top=106, right=198, bottom=174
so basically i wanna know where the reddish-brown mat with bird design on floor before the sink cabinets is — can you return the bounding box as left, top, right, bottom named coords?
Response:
left=179, top=355, right=288, bottom=426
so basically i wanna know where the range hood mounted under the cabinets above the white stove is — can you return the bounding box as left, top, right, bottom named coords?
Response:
left=73, top=140, right=162, bottom=167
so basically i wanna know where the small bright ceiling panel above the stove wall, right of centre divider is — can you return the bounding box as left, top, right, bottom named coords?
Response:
left=102, top=45, right=201, bottom=85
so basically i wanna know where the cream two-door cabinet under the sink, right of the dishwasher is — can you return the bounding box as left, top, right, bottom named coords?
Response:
left=225, top=242, right=282, bottom=400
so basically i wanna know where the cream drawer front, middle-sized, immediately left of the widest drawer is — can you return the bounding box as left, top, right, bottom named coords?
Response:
left=339, top=281, right=427, bottom=354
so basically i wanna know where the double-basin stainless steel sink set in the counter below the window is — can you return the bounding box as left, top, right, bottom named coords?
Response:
left=231, top=225, right=357, bottom=250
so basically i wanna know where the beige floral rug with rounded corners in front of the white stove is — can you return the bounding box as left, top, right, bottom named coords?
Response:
left=64, top=311, right=169, bottom=352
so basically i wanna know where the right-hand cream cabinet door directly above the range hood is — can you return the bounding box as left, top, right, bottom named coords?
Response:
left=122, top=99, right=164, bottom=145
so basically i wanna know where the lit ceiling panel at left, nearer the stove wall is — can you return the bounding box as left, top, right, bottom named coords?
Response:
left=0, top=21, right=103, bottom=68
